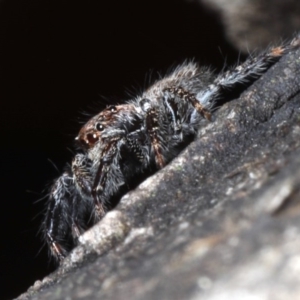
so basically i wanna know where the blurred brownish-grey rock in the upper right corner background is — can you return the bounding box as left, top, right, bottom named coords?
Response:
left=198, top=0, right=300, bottom=54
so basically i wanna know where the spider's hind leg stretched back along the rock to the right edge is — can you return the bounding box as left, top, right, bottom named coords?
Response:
left=196, top=36, right=300, bottom=107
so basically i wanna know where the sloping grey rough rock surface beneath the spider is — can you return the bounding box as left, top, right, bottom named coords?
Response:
left=18, top=43, right=300, bottom=300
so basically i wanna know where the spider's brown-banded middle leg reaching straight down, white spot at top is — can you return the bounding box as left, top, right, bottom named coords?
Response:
left=139, top=98, right=166, bottom=168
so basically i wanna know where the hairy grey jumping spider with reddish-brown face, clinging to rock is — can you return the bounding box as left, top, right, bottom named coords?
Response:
left=43, top=37, right=300, bottom=261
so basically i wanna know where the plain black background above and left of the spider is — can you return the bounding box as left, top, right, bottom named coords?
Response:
left=0, top=0, right=238, bottom=299
